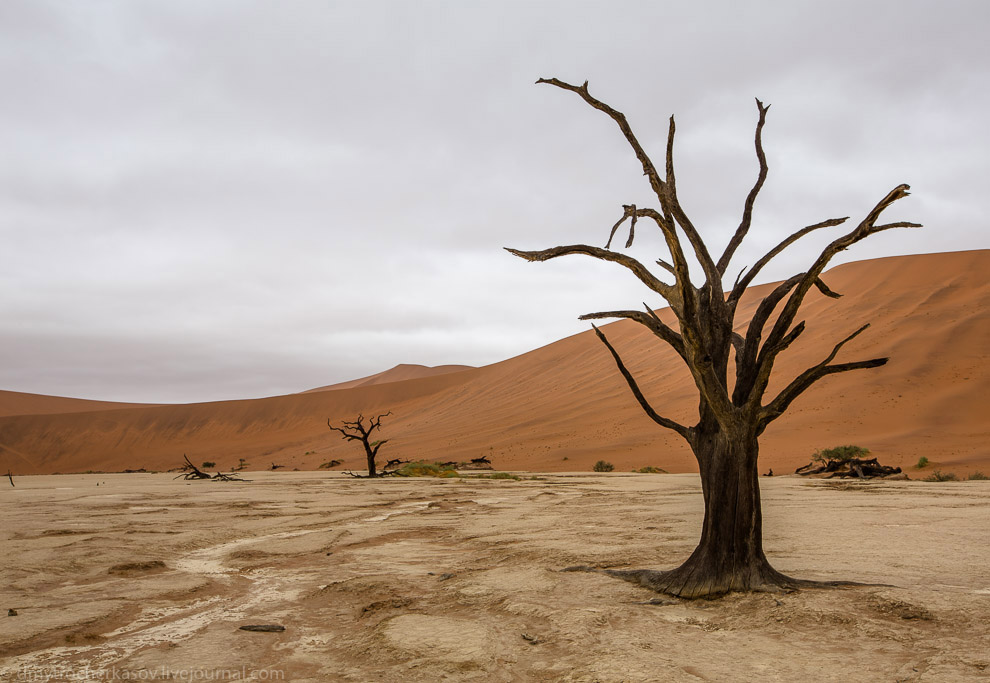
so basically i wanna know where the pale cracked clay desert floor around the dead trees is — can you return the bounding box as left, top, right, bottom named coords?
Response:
left=0, top=472, right=990, bottom=681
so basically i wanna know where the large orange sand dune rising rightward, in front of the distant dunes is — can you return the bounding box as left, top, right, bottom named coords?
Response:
left=0, top=250, right=990, bottom=474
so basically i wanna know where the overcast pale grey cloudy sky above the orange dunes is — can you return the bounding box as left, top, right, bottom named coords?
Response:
left=0, top=0, right=990, bottom=402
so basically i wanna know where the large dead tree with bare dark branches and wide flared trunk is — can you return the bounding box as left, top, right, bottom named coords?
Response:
left=508, top=78, right=920, bottom=597
